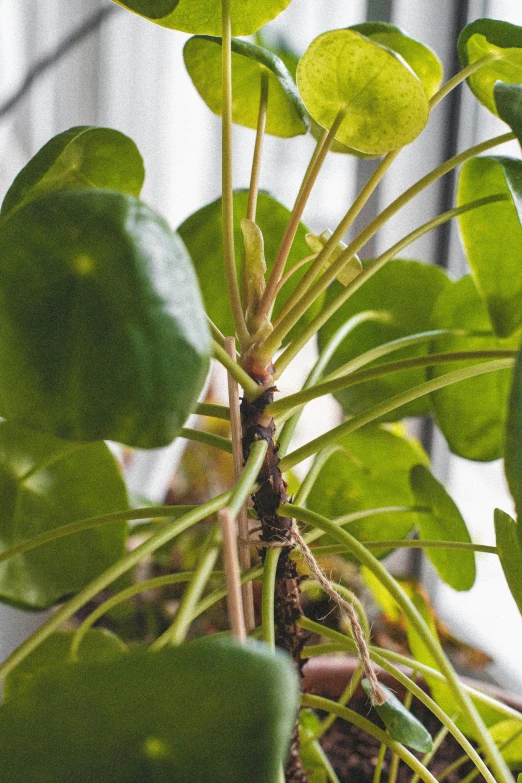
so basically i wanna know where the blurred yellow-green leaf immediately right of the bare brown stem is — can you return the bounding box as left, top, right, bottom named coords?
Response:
left=307, top=427, right=428, bottom=556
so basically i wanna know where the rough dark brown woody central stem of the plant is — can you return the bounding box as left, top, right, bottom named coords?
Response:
left=241, top=386, right=308, bottom=783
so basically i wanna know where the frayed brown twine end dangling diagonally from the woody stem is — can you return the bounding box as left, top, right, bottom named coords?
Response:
left=292, top=520, right=388, bottom=705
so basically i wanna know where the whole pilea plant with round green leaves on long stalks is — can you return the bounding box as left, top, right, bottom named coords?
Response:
left=0, top=0, right=522, bottom=783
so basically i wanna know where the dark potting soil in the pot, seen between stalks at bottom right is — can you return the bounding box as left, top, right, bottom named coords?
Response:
left=321, top=699, right=516, bottom=783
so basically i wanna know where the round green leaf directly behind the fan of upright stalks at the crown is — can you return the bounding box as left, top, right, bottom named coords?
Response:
left=178, top=190, right=322, bottom=342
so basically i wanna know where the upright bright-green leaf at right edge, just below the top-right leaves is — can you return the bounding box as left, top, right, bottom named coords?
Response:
left=457, top=156, right=522, bottom=337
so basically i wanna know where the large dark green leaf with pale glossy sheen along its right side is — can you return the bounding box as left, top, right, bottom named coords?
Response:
left=0, top=189, right=210, bottom=448
